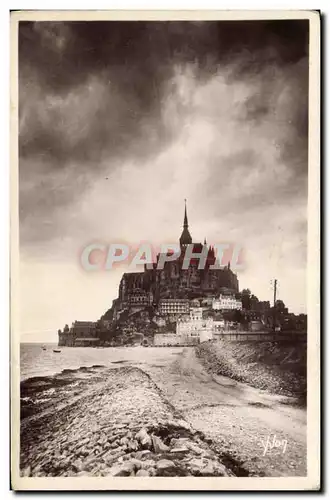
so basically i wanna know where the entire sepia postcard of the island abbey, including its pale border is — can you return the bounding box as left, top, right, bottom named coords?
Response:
left=11, top=11, right=320, bottom=491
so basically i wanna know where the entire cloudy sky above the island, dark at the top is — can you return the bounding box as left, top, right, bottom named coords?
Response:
left=19, top=21, right=308, bottom=341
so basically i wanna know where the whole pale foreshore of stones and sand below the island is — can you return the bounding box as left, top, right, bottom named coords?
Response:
left=20, top=346, right=306, bottom=477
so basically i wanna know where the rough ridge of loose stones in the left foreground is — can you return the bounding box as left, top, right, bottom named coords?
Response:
left=20, top=368, right=233, bottom=476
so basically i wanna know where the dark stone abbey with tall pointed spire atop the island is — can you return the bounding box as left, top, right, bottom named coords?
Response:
left=111, top=202, right=239, bottom=320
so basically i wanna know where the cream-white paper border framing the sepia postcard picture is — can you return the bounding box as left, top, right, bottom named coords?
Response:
left=11, top=10, right=320, bottom=490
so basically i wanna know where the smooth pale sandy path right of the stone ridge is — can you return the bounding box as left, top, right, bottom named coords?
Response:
left=140, top=348, right=306, bottom=476
